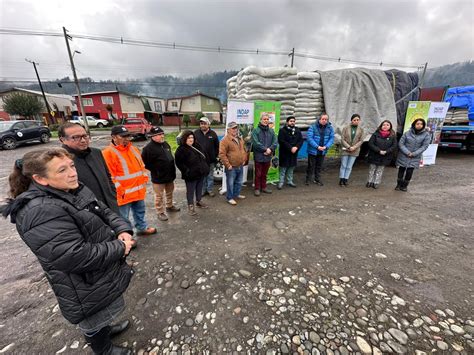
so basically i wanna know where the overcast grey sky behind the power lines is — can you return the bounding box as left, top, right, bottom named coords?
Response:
left=0, top=0, right=474, bottom=80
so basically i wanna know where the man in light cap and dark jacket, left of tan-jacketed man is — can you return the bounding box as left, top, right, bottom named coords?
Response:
left=194, top=116, right=219, bottom=197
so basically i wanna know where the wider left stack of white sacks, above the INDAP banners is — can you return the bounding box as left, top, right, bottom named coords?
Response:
left=227, top=66, right=298, bottom=120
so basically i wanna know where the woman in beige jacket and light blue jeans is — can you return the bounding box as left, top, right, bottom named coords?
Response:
left=339, top=113, right=364, bottom=186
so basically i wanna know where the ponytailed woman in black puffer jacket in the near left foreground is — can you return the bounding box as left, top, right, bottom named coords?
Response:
left=2, top=148, right=133, bottom=354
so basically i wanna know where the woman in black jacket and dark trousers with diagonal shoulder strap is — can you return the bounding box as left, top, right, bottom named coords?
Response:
left=175, top=131, right=209, bottom=216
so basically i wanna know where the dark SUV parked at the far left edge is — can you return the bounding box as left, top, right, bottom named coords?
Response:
left=0, top=120, right=51, bottom=150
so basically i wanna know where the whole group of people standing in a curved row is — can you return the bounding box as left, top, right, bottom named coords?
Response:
left=1, top=114, right=429, bottom=355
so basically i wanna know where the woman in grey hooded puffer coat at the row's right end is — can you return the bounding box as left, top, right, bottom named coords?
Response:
left=395, top=118, right=431, bottom=192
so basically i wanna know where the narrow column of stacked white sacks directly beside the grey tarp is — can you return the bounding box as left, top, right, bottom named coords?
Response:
left=294, top=72, right=324, bottom=128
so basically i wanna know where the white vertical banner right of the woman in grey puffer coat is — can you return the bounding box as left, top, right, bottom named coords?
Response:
left=423, top=102, right=449, bottom=165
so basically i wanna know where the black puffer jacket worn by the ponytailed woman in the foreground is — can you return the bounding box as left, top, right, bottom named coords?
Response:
left=2, top=183, right=133, bottom=324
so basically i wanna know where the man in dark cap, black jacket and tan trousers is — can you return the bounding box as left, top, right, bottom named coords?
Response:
left=142, top=127, right=180, bottom=221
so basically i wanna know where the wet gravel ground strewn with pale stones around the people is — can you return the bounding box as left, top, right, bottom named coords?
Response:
left=0, top=137, right=474, bottom=354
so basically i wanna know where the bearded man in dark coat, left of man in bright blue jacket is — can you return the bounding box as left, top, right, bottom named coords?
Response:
left=277, top=116, right=303, bottom=190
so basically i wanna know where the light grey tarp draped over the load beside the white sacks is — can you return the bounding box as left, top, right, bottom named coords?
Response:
left=319, top=68, right=397, bottom=142
